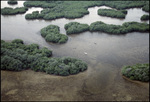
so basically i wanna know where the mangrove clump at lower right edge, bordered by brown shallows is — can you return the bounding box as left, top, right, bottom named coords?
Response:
left=121, top=64, right=149, bottom=82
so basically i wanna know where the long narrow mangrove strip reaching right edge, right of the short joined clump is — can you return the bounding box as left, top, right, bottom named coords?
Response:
left=90, top=21, right=149, bottom=34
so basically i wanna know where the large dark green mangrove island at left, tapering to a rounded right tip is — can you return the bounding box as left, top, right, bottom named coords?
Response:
left=1, top=39, right=87, bottom=76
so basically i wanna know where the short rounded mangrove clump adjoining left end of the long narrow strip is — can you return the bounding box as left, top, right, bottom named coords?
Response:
left=65, top=22, right=89, bottom=34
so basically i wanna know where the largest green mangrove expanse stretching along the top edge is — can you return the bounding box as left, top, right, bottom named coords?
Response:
left=24, top=1, right=149, bottom=20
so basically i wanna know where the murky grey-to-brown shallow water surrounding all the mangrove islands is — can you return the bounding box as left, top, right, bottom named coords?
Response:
left=1, top=1, right=149, bottom=101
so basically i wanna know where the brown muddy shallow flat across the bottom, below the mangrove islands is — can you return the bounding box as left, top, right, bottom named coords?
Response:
left=1, top=63, right=149, bottom=101
